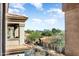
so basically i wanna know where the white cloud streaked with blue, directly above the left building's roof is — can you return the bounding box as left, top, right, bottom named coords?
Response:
left=9, top=3, right=25, bottom=15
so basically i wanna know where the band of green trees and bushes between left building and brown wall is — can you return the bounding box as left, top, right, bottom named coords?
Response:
left=26, top=28, right=65, bottom=47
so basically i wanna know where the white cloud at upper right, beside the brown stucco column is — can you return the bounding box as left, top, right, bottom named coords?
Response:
left=44, top=8, right=64, bottom=20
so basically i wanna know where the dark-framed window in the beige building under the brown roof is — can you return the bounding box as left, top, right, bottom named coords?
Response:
left=8, top=24, right=19, bottom=39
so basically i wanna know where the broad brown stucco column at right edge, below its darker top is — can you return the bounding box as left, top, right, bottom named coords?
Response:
left=65, top=8, right=79, bottom=55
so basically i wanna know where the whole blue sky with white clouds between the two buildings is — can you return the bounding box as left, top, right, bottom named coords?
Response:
left=9, top=3, right=65, bottom=30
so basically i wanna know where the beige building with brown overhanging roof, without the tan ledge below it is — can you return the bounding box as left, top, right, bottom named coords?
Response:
left=6, top=14, right=28, bottom=46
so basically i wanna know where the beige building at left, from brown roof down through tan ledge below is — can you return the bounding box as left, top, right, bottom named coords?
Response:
left=6, top=13, right=28, bottom=54
